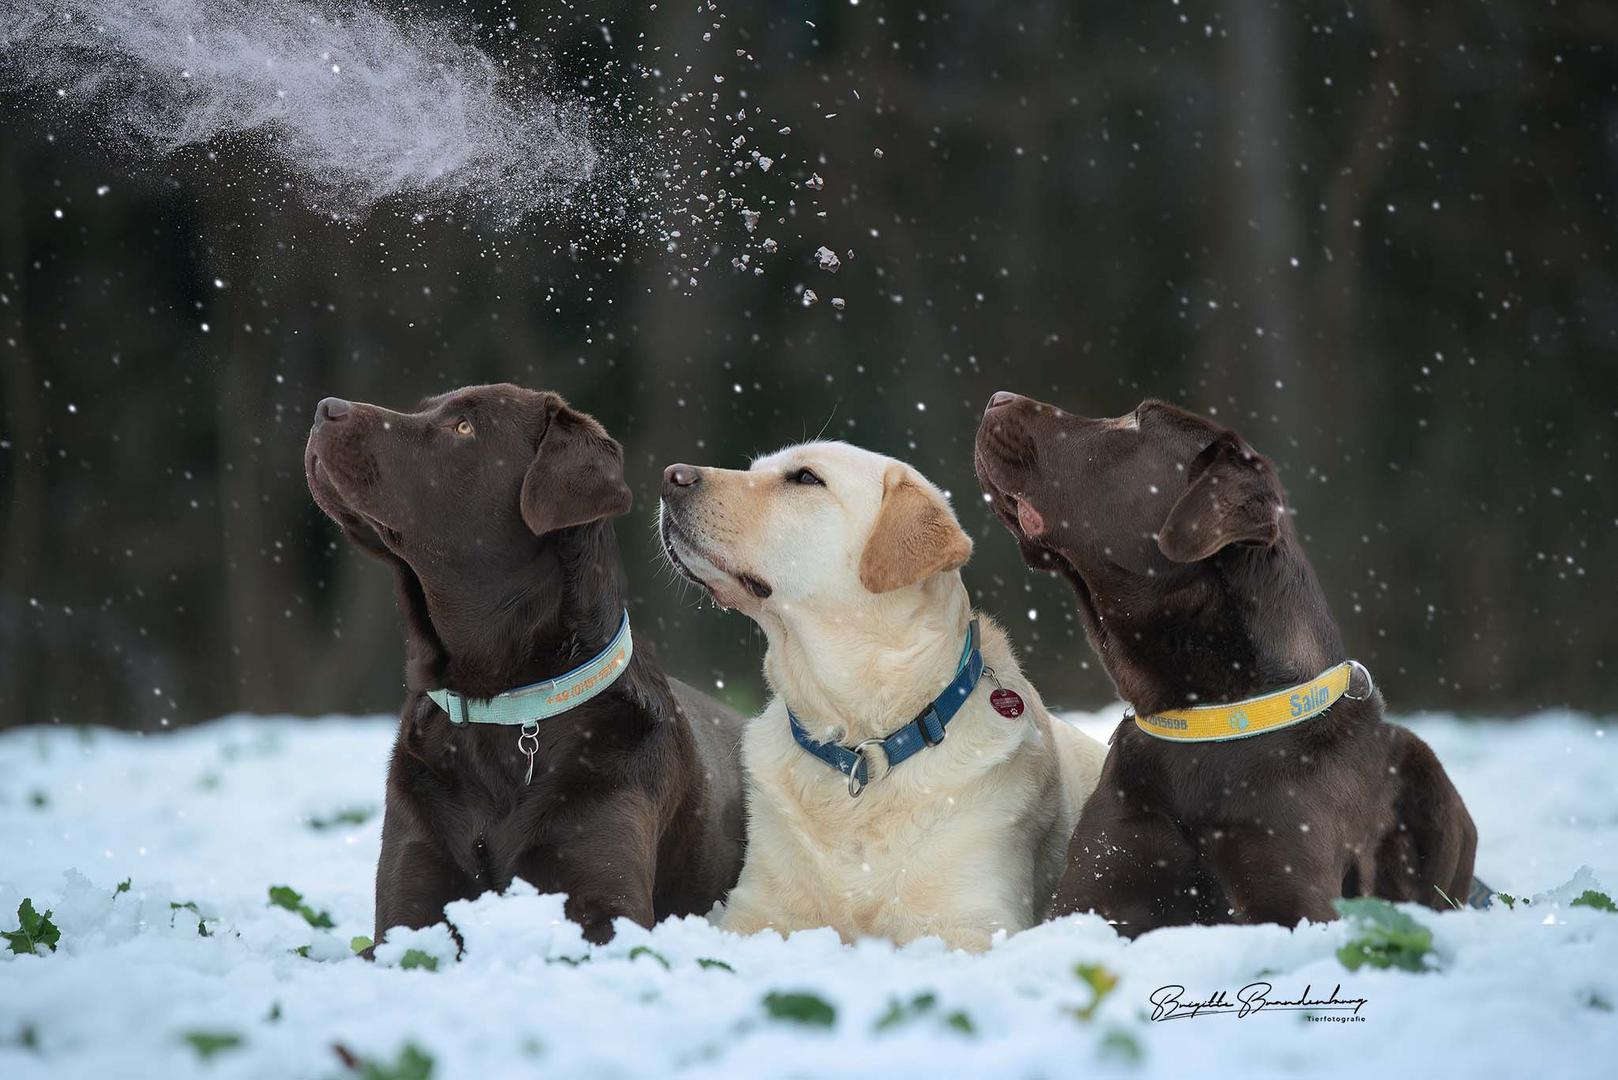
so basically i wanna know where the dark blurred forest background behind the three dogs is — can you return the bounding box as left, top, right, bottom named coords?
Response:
left=0, top=0, right=1618, bottom=729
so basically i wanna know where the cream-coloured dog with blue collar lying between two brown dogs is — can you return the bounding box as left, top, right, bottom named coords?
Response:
left=660, top=442, right=1105, bottom=949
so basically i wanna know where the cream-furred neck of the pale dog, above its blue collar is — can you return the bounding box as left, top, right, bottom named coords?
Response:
left=760, top=572, right=972, bottom=743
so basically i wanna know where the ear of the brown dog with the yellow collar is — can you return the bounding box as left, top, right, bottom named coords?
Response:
left=1157, top=431, right=1285, bottom=562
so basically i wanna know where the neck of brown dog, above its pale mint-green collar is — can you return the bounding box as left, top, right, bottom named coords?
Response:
left=400, top=521, right=628, bottom=698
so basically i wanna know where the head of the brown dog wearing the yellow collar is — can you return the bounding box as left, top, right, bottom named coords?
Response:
left=974, top=390, right=1290, bottom=696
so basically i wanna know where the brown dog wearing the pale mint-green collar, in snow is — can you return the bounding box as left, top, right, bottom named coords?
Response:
left=304, top=385, right=744, bottom=941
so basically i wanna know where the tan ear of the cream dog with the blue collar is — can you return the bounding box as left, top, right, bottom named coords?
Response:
left=859, top=465, right=972, bottom=593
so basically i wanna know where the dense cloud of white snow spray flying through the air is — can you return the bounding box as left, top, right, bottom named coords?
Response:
left=0, top=0, right=597, bottom=223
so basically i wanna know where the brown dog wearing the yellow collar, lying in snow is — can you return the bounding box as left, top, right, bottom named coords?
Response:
left=974, top=392, right=1477, bottom=934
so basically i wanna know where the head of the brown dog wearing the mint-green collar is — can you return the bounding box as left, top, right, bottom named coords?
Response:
left=304, top=384, right=629, bottom=678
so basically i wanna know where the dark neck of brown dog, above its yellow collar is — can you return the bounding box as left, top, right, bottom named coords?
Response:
left=1092, top=534, right=1346, bottom=714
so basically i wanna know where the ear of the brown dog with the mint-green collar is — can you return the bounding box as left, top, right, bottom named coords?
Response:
left=521, top=405, right=631, bottom=536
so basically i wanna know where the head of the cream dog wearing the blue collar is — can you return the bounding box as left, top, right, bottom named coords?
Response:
left=659, top=442, right=972, bottom=620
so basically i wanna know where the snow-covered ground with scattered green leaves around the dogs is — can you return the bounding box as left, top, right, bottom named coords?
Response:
left=0, top=711, right=1618, bottom=1080
